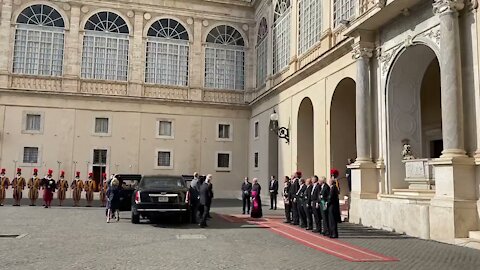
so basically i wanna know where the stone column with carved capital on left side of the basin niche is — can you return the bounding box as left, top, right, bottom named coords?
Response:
left=353, top=43, right=373, bottom=163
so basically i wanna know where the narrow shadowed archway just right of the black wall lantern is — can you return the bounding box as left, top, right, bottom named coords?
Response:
left=297, top=97, right=314, bottom=177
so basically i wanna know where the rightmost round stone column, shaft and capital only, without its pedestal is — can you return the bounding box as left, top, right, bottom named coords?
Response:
left=433, top=0, right=465, bottom=157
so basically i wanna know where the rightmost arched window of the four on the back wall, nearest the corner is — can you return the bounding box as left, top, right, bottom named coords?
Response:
left=205, top=25, right=245, bottom=90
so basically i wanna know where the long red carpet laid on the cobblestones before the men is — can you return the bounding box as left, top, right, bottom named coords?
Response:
left=219, top=215, right=398, bottom=262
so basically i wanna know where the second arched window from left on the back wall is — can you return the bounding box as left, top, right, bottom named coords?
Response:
left=82, top=11, right=129, bottom=81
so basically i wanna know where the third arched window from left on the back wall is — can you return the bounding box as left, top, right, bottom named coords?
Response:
left=145, top=19, right=188, bottom=86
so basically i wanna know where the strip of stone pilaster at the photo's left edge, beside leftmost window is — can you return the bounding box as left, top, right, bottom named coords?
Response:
left=0, top=0, right=12, bottom=88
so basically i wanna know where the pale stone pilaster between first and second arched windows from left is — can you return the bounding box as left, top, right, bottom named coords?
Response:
left=63, top=3, right=82, bottom=92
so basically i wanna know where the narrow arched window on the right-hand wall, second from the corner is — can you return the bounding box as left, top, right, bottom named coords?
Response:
left=273, top=0, right=292, bottom=74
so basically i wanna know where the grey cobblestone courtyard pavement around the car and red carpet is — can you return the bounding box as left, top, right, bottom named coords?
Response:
left=0, top=198, right=480, bottom=270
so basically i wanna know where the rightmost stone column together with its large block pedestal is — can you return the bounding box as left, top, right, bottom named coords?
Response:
left=429, top=0, right=478, bottom=240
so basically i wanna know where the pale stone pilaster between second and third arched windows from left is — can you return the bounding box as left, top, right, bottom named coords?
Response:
left=128, top=11, right=143, bottom=96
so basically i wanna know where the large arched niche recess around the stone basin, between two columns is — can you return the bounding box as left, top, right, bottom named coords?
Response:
left=385, top=42, right=441, bottom=191
